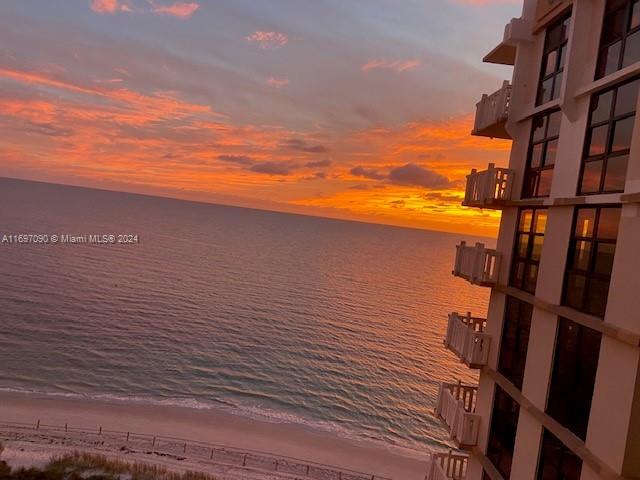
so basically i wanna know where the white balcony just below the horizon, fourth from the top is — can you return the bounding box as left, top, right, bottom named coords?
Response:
left=451, top=241, right=501, bottom=287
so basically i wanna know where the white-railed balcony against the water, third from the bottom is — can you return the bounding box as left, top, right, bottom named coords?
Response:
left=444, top=312, right=491, bottom=368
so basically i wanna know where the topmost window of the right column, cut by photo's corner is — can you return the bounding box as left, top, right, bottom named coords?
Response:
left=596, top=0, right=640, bottom=80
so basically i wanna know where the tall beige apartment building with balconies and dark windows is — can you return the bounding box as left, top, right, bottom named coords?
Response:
left=428, top=0, right=640, bottom=480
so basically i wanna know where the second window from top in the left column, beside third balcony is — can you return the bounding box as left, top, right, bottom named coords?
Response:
left=522, top=110, right=562, bottom=198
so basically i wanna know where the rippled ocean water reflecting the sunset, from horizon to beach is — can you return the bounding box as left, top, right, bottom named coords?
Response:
left=0, top=179, right=488, bottom=458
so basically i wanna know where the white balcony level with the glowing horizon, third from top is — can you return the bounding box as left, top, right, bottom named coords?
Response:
left=462, top=163, right=515, bottom=210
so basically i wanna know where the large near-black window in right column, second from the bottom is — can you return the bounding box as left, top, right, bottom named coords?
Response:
left=547, top=318, right=602, bottom=440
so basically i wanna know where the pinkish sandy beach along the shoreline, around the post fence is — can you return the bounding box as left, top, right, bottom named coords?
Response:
left=0, top=393, right=429, bottom=480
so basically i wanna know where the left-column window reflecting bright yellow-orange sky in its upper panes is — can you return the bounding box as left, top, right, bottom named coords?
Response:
left=509, top=208, right=547, bottom=293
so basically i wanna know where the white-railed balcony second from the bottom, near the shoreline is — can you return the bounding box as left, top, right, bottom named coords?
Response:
left=435, top=382, right=481, bottom=450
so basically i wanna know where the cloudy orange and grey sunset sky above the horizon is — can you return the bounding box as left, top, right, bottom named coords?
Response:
left=0, top=0, right=521, bottom=235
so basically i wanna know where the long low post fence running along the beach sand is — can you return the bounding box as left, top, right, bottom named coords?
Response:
left=0, top=420, right=391, bottom=480
